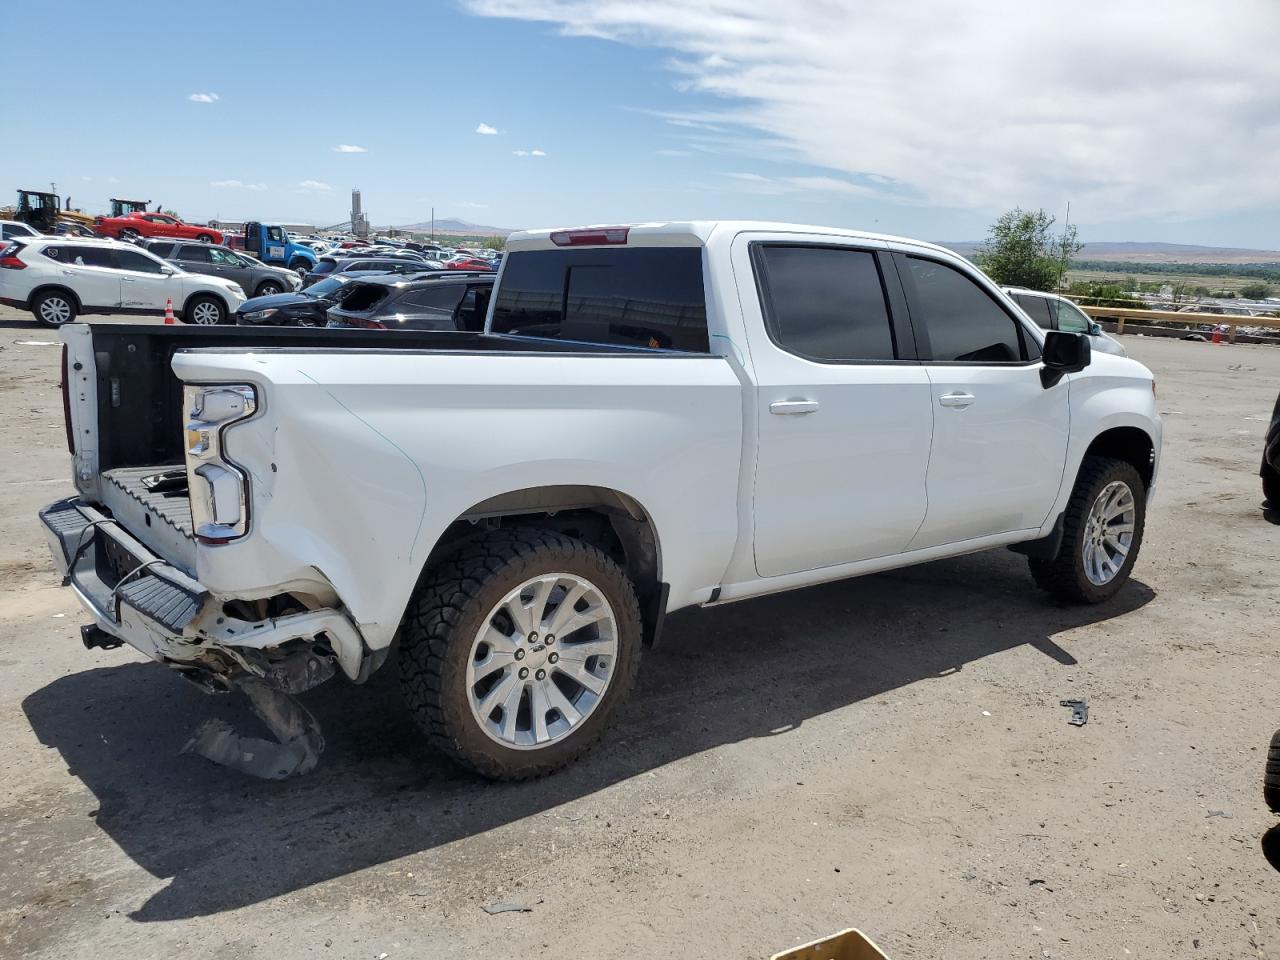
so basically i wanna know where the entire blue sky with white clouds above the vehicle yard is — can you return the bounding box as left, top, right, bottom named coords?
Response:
left=0, top=0, right=1280, bottom=248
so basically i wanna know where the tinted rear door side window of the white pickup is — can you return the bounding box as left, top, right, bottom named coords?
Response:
left=756, top=244, right=896, bottom=361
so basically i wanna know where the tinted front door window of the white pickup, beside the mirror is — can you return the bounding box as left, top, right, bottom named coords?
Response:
left=906, top=257, right=1027, bottom=364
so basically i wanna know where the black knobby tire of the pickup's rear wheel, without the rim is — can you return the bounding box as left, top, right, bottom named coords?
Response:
left=399, top=527, right=641, bottom=781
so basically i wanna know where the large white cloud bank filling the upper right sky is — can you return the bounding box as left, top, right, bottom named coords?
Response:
left=465, top=0, right=1280, bottom=221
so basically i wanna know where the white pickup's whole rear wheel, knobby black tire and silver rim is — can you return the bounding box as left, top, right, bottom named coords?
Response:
left=399, top=527, right=641, bottom=780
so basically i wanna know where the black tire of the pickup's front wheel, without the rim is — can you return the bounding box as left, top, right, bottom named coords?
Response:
left=1028, top=457, right=1147, bottom=603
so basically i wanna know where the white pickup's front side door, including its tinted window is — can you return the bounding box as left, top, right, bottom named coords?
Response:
left=895, top=253, right=1070, bottom=549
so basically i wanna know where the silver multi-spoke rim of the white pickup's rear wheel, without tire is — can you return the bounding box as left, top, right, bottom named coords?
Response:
left=466, top=573, right=618, bottom=750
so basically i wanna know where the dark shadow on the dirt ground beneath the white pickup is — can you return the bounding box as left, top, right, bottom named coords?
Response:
left=23, top=553, right=1155, bottom=922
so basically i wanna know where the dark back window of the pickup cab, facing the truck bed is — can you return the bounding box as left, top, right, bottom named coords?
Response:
left=493, top=247, right=708, bottom=353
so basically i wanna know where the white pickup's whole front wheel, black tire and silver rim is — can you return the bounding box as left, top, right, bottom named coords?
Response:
left=1029, top=457, right=1147, bottom=603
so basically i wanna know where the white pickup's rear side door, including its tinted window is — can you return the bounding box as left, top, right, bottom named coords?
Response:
left=733, top=234, right=933, bottom=577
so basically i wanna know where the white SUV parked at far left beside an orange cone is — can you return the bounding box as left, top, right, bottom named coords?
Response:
left=0, top=237, right=246, bottom=326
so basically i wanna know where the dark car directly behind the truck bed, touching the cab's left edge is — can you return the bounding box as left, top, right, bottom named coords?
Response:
left=328, top=270, right=494, bottom=333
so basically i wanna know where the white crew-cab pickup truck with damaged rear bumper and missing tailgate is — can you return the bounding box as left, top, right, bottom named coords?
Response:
left=41, top=221, right=1161, bottom=780
